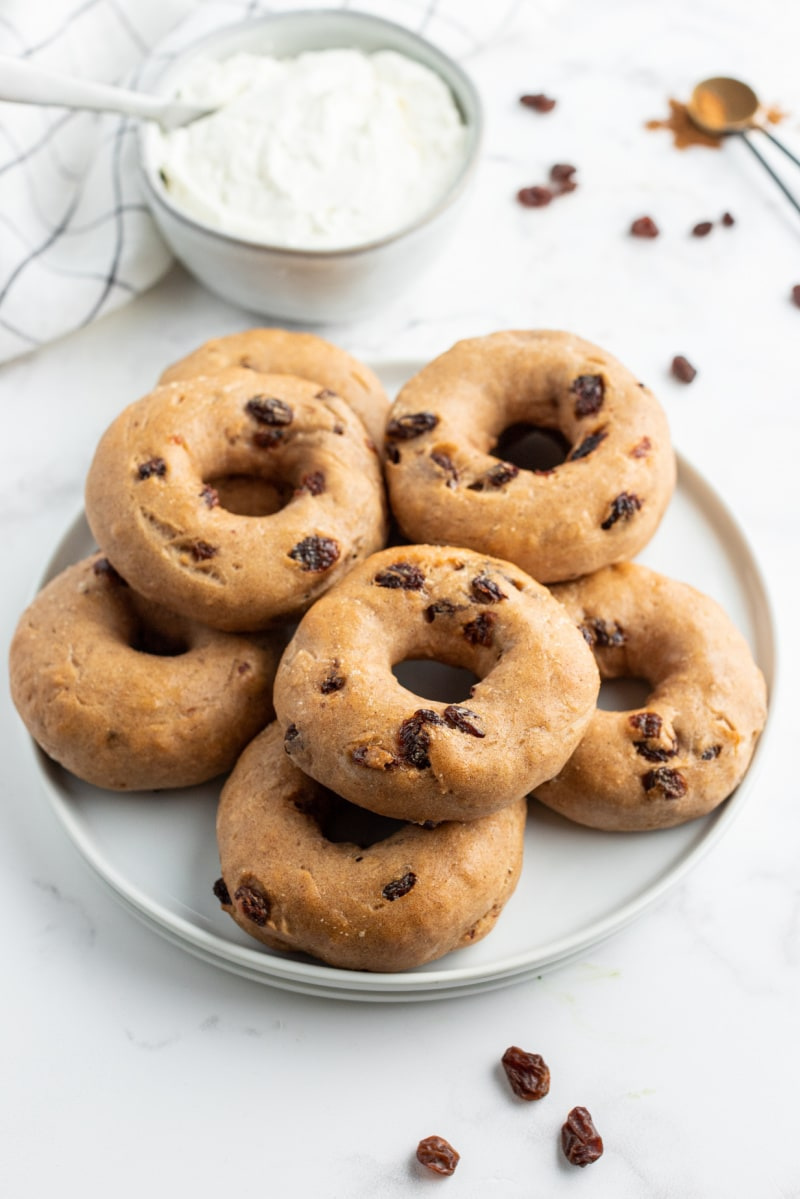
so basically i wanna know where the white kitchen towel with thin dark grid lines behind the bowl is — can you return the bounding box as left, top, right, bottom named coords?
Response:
left=0, top=0, right=537, bottom=361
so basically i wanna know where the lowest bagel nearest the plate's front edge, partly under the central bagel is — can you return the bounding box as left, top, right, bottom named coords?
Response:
left=215, top=724, right=525, bottom=971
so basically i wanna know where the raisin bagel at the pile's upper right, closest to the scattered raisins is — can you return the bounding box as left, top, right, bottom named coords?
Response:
left=386, top=331, right=675, bottom=583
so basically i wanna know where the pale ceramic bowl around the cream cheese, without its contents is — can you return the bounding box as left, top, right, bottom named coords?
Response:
left=139, top=10, right=482, bottom=324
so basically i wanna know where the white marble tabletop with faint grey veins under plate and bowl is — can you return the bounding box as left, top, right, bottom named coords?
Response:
left=0, top=0, right=800, bottom=1199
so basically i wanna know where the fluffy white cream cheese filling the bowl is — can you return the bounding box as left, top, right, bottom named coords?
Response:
left=154, top=48, right=467, bottom=251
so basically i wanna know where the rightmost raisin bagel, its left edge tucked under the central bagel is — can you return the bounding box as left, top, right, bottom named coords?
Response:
left=535, top=562, right=766, bottom=831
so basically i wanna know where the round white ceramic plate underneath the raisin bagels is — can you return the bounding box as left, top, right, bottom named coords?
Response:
left=29, top=362, right=775, bottom=1002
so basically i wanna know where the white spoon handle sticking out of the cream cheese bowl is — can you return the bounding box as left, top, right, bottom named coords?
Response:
left=0, top=55, right=213, bottom=129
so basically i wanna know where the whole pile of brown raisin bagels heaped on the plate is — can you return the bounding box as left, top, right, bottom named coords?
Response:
left=11, top=330, right=766, bottom=971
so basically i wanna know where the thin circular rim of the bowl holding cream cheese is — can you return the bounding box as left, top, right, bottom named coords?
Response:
left=137, top=8, right=483, bottom=261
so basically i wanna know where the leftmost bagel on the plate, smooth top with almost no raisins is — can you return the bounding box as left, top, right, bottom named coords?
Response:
left=10, top=555, right=282, bottom=790
